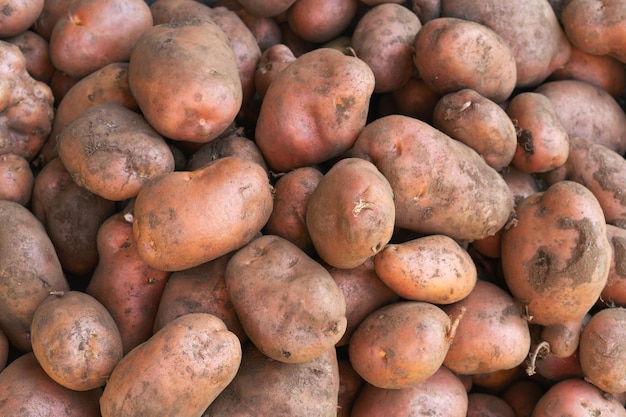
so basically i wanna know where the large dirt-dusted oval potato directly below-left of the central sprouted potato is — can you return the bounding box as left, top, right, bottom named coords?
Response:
left=225, top=235, right=346, bottom=363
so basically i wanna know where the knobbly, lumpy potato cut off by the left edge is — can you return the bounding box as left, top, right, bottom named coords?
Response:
left=0, top=40, right=54, bottom=161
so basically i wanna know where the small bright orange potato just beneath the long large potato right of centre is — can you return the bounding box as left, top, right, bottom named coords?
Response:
left=374, top=235, right=478, bottom=304
